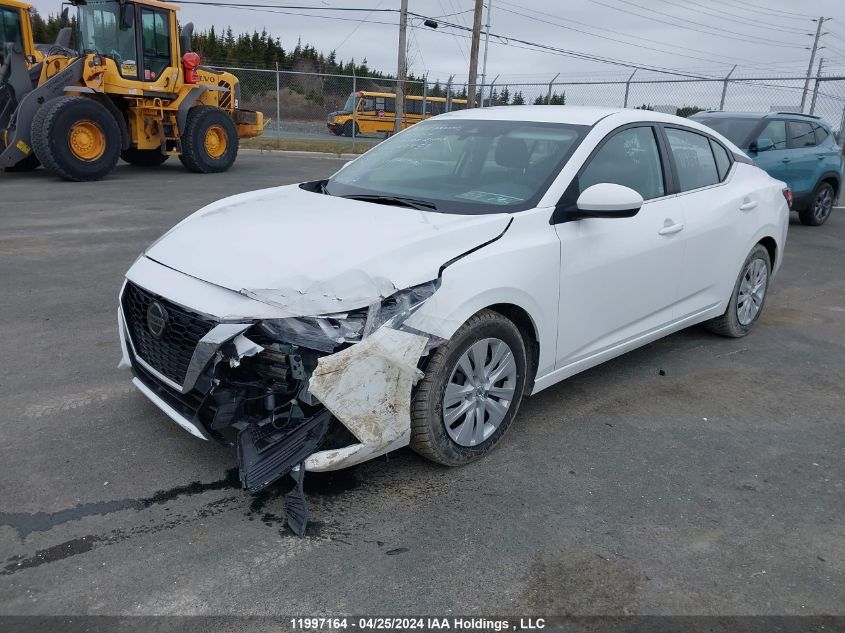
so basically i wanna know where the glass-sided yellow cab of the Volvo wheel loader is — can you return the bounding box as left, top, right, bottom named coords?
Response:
left=72, top=0, right=182, bottom=87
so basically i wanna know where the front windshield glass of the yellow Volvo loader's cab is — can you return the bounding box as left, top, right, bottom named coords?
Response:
left=77, top=0, right=136, bottom=65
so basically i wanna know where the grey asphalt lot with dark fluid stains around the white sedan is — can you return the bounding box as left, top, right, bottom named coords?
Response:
left=0, top=152, right=845, bottom=615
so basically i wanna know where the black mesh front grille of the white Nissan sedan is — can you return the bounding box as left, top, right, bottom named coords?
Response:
left=121, top=282, right=217, bottom=385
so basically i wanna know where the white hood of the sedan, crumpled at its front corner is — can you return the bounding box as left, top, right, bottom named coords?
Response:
left=145, top=185, right=510, bottom=316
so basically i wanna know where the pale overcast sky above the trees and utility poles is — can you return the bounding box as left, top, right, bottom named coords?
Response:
left=30, top=0, right=845, bottom=81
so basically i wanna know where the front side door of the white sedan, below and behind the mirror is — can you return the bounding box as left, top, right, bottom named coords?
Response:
left=555, top=124, right=684, bottom=368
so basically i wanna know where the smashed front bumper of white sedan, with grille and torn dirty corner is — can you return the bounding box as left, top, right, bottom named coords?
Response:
left=118, top=281, right=440, bottom=491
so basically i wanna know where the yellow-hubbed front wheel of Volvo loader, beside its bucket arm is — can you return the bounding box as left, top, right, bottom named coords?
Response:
left=32, top=96, right=120, bottom=182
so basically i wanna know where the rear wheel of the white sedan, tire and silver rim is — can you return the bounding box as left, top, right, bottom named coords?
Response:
left=704, top=244, right=772, bottom=338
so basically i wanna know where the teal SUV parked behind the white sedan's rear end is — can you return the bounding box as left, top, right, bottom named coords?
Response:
left=690, top=111, right=843, bottom=226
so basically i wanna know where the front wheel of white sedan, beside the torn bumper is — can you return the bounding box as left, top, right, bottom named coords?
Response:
left=411, top=310, right=527, bottom=466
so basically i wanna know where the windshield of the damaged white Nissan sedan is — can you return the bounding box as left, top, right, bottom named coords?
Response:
left=325, top=119, right=589, bottom=214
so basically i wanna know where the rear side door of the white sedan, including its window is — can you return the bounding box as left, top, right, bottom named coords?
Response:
left=663, top=126, right=760, bottom=320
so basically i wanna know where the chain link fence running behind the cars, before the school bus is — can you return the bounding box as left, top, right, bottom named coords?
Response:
left=220, top=66, right=845, bottom=148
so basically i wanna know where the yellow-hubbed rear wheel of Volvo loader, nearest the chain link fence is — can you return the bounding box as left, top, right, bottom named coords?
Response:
left=179, top=106, right=238, bottom=174
